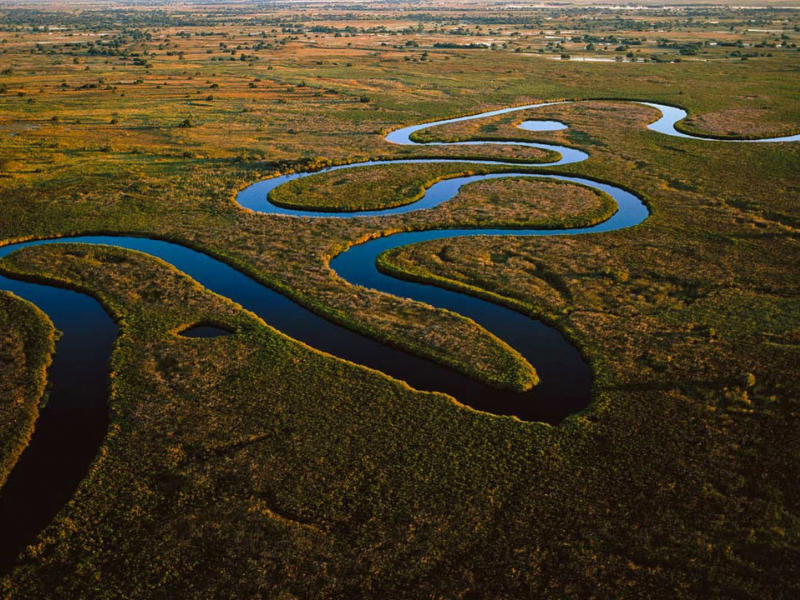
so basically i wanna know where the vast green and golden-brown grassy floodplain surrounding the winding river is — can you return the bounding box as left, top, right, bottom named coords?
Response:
left=0, top=3, right=800, bottom=599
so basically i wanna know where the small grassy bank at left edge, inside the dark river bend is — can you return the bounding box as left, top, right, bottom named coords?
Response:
left=0, top=292, right=55, bottom=487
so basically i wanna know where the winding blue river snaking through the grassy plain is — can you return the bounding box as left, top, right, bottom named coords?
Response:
left=0, top=103, right=800, bottom=574
